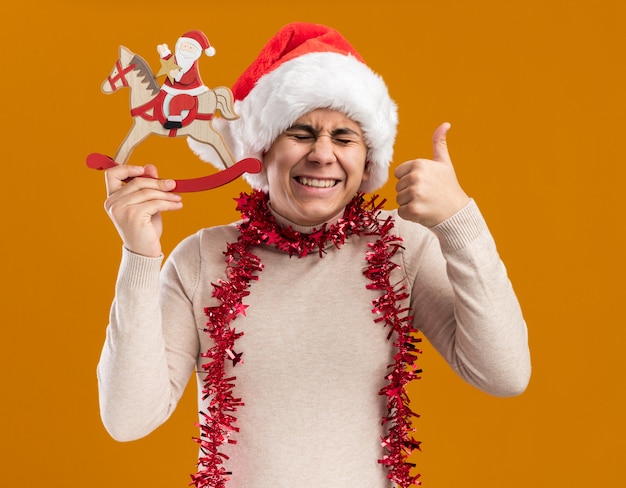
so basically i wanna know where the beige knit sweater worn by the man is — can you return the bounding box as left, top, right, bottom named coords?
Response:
left=98, top=201, right=530, bottom=488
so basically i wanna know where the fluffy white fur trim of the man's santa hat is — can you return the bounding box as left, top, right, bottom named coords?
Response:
left=188, top=52, right=398, bottom=192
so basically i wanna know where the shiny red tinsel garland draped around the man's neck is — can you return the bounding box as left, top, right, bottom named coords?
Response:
left=191, top=191, right=421, bottom=488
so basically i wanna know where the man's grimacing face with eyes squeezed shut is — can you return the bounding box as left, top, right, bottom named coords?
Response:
left=263, top=109, right=370, bottom=225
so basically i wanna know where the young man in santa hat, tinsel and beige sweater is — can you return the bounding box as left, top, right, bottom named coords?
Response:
left=98, top=24, right=530, bottom=488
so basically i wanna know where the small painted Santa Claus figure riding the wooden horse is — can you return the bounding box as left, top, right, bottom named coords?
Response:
left=157, top=30, right=215, bottom=129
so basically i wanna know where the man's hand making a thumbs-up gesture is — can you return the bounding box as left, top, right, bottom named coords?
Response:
left=394, top=122, right=469, bottom=227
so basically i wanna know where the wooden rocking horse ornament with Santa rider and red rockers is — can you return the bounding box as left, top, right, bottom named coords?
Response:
left=87, top=30, right=261, bottom=192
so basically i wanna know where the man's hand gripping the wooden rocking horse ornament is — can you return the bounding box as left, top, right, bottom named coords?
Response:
left=104, top=164, right=183, bottom=257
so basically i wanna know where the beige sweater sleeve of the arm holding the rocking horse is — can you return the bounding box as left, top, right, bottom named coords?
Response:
left=97, top=241, right=199, bottom=441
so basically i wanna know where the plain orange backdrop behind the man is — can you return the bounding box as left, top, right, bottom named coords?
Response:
left=0, top=0, right=626, bottom=488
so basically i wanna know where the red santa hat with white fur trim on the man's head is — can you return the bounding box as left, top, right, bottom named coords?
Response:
left=188, top=23, right=398, bottom=192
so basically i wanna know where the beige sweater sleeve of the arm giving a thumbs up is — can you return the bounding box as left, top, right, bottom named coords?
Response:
left=405, top=200, right=531, bottom=396
